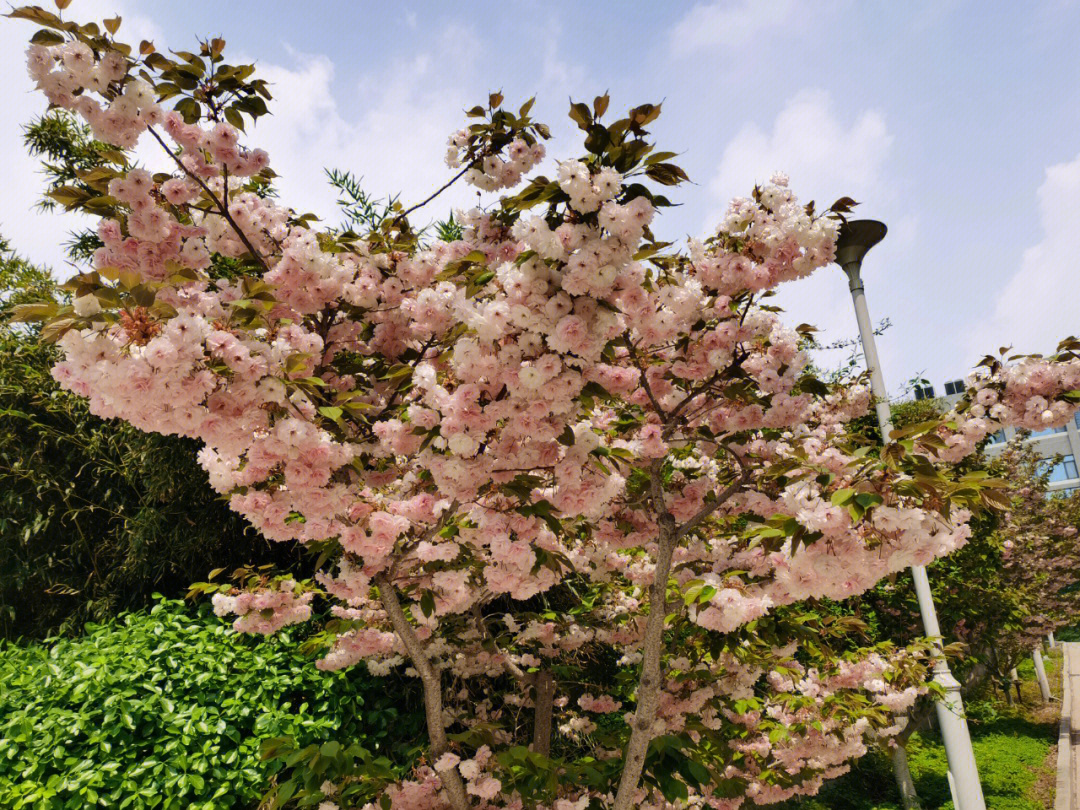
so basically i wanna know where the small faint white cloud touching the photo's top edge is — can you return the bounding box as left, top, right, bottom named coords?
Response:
left=670, top=0, right=795, bottom=53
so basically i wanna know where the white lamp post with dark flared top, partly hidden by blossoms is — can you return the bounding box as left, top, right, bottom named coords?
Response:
left=836, top=219, right=986, bottom=810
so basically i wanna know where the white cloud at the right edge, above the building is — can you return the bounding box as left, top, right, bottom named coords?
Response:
left=966, top=154, right=1080, bottom=361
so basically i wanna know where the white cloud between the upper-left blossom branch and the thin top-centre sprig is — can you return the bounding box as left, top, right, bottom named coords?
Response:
left=248, top=28, right=488, bottom=228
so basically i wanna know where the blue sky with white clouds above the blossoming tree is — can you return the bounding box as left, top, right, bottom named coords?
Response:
left=0, top=0, right=1080, bottom=393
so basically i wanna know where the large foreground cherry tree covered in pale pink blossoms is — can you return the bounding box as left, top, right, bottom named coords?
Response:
left=10, top=2, right=1080, bottom=810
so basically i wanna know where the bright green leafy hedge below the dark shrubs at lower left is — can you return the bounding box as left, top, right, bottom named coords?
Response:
left=0, top=600, right=422, bottom=810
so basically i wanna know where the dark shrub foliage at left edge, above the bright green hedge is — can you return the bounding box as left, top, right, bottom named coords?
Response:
left=0, top=242, right=300, bottom=638
